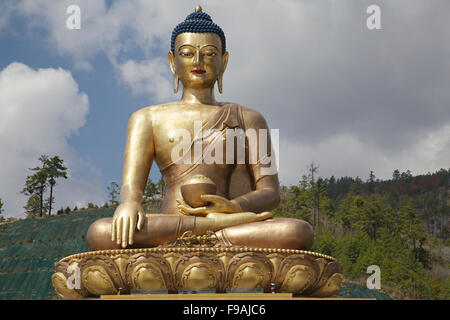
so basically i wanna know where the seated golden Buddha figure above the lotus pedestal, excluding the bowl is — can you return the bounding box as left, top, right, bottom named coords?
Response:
left=87, top=6, right=313, bottom=250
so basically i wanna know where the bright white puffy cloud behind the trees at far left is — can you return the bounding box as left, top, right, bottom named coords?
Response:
left=0, top=62, right=104, bottom=217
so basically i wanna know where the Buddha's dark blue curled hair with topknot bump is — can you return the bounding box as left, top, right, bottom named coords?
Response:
left=170, top=11, right=226, bottom=54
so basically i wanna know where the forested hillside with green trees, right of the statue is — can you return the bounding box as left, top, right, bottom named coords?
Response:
left=274, top=168, right=450, bottom=299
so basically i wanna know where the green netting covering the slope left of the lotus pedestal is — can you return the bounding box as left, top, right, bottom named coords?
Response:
left=0, top=209, right=114, bottom=299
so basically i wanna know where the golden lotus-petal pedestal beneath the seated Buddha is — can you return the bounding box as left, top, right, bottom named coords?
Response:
left=52, top=247, right=343, bottom=299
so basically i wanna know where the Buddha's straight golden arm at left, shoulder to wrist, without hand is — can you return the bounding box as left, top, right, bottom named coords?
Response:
left=120, top=108, right=155, bottom=203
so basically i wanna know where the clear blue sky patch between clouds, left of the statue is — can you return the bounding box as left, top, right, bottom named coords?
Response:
left=0, top=5, right=158, bottom=185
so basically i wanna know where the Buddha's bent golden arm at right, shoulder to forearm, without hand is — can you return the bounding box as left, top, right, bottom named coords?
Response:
left=233, top=109, right=280, bottom=213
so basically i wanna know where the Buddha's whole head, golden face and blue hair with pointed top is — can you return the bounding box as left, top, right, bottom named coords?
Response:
left=169, top=6, right=228, bottom=93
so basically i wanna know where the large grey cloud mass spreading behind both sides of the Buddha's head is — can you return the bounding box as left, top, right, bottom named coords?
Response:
left=8, top=0, right=450, bottom=183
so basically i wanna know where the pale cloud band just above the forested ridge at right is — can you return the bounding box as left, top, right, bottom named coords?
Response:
left=279, top=125, right=450, bottom=185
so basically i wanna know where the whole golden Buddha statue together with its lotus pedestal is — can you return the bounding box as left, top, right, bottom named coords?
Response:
left=52, top=6, right=343, bottom=299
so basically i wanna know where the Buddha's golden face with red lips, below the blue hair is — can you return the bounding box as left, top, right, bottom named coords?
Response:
left=169, top=33, right=228, bottom=89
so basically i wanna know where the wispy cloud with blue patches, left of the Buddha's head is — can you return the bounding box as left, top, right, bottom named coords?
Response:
left=14, top=0, right=186, bottom=102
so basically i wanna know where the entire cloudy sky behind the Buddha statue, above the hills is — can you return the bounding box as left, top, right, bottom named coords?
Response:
left=0, top=0, right=450, bottom=217
